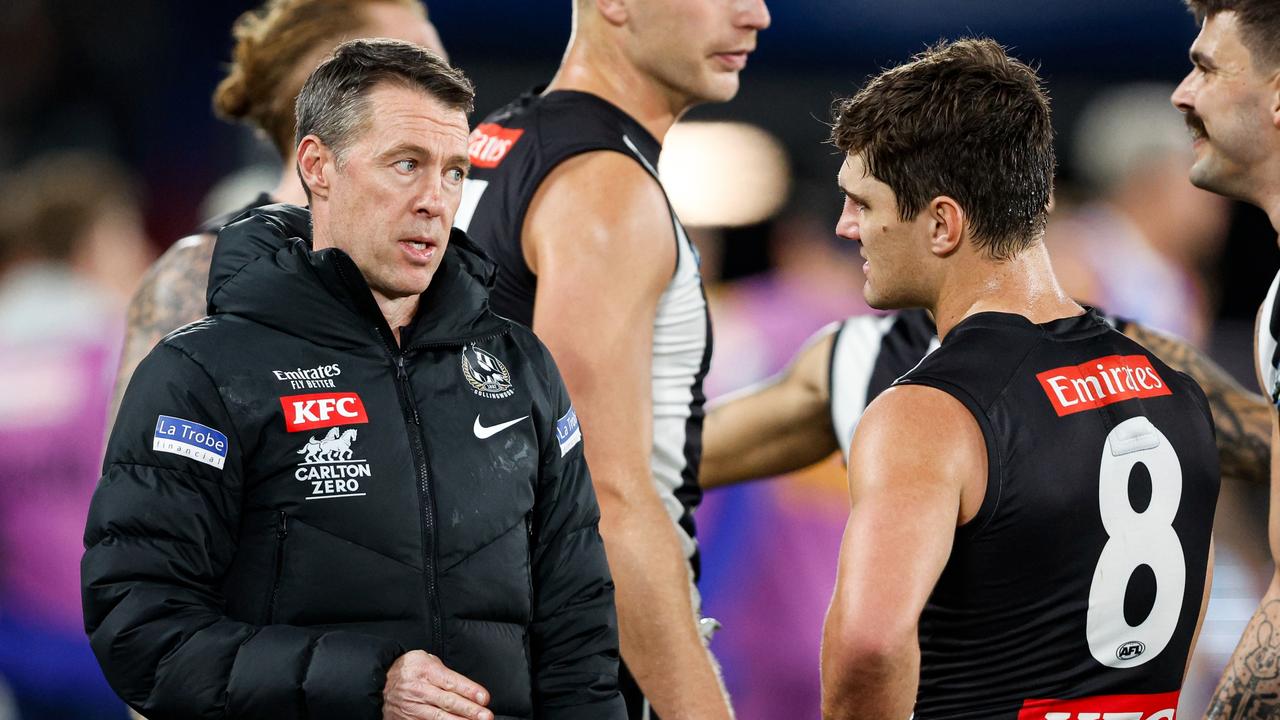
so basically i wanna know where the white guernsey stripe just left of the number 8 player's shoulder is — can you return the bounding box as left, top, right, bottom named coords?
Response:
left=828, top=315, right=897, bottom=464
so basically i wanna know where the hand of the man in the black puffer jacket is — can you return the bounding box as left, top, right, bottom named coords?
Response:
left=383, top=650, right=493, bottom=720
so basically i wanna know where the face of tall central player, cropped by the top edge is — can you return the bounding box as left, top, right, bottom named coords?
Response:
left=628, top=0, right=769, bottom=105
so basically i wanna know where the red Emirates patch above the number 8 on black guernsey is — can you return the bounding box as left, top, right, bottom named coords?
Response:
left=1036, top=355, right=1172, bottom=418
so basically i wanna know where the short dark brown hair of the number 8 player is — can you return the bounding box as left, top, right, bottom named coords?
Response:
left=831, top=38, right=1055, bottom=260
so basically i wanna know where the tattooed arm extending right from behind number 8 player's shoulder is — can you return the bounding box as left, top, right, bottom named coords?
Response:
left=1125, top=323, right=1280, bottom=484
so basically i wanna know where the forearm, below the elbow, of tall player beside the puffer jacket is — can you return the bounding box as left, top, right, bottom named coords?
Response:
left=600, top=488, right=732, bottom=720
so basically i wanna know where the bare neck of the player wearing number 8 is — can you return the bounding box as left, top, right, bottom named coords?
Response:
left=929, top=242, right=1080, bottom=338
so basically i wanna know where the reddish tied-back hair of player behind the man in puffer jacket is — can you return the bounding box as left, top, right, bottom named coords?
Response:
left=214, top=0, right=426, bottom=158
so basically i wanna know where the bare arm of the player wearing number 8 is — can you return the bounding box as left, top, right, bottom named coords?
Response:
left=822, top=386, right=987, bottom=720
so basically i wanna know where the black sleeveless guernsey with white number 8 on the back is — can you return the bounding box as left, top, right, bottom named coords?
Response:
left=897, top=310, right=1219, bottom=720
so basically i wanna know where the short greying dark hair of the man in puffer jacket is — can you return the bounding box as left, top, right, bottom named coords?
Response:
left=294, top=38, right=476, bottom=159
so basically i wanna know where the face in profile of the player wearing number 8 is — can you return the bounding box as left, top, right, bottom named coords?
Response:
left=836, top=154, right=931, bottom=310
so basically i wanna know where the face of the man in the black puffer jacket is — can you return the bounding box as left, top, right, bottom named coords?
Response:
left=315, top=82, right=468, bottom=299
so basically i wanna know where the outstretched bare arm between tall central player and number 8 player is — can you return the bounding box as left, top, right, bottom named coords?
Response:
left=698, top=328, right=840, bottom=488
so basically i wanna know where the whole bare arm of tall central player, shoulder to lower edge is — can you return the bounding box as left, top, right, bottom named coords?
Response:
left=524, top=152, right=731, bottom=720
